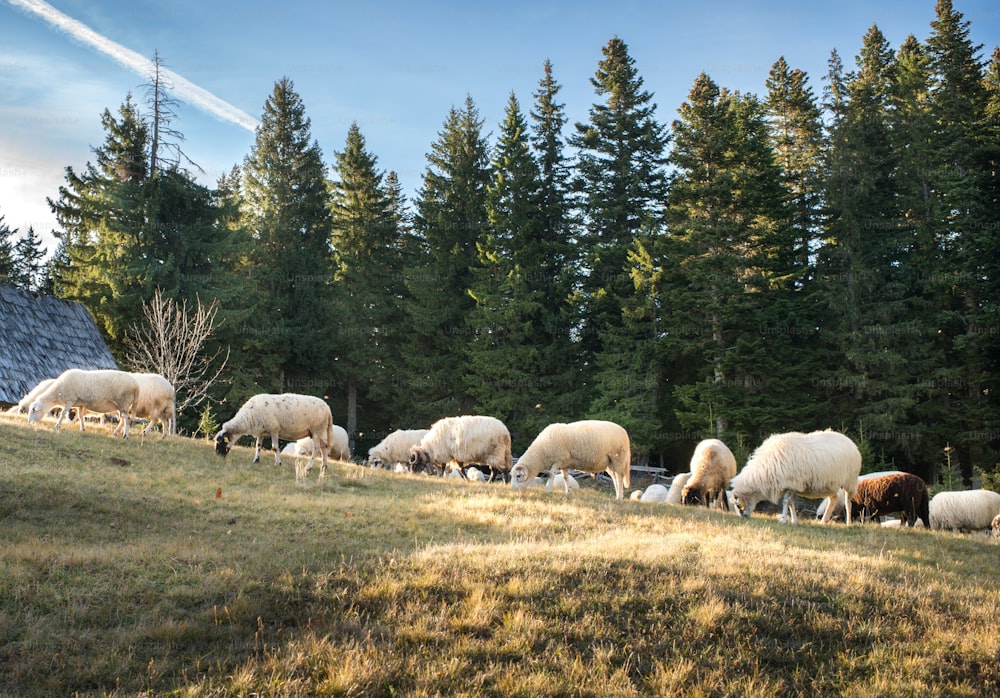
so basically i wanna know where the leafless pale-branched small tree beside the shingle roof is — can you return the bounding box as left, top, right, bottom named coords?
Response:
left=126, top=289, right=229, bottom=428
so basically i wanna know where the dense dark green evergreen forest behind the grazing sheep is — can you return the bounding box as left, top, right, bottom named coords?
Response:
left=0, top=0, right=1000, bottom=482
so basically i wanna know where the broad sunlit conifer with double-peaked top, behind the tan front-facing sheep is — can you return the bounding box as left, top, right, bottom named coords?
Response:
left=662, top=74, right=792, bottom=438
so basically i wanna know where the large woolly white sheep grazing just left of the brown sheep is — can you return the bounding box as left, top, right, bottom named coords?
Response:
left=731, top=429, right=861, bottom=525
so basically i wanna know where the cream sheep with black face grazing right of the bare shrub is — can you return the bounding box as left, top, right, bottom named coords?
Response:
left=215, top=393, right=333, bottom=480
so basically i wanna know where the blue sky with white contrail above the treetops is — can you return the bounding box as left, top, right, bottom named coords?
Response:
left=0, top=0, right=1000, bottom=253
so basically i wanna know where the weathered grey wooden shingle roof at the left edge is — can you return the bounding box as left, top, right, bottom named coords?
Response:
left=0, top=284, right=118, bottom=404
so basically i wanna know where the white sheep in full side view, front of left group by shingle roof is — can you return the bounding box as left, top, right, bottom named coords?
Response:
left=28, top=368, right=139, bottom=439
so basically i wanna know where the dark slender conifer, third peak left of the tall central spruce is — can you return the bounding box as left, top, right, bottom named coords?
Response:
left=400, top=92, right=490, bottom=423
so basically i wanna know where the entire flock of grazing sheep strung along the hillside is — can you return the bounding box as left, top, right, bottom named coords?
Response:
left=14, top=369, right=1000, bottom=535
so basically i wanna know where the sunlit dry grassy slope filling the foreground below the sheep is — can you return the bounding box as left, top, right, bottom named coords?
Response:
left=0, top=410, right=1000, bottom=698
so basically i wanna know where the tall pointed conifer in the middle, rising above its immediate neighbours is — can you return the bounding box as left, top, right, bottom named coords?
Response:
left=570, top=37, right=668, bottom=436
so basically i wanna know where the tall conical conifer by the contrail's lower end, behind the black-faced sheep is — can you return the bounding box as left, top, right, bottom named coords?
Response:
left=241, top=78, right=336, bottom=393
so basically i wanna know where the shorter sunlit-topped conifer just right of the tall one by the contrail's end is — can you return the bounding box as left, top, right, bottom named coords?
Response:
left=331, top=124, right=406, bottom=439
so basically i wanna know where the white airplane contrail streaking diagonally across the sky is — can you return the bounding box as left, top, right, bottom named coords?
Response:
left=9, top=0, right=258, bottom=131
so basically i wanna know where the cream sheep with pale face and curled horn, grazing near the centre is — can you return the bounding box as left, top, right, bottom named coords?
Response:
left=510, top=419, right=632, bottom=499
